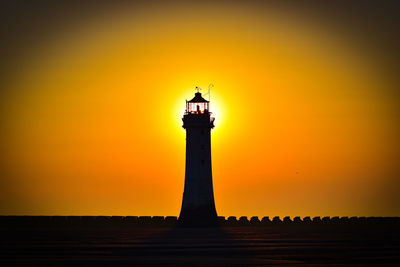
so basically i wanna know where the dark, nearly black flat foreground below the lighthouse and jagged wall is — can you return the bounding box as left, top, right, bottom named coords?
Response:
left=0, top=218, right=400, bottom=266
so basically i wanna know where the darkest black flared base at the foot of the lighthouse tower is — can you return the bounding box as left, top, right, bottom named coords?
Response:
left=178, top=204, right=218, bottom=227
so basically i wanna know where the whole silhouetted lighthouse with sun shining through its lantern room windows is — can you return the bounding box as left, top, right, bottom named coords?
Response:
left=178, top=87, right=218, bottom=226
